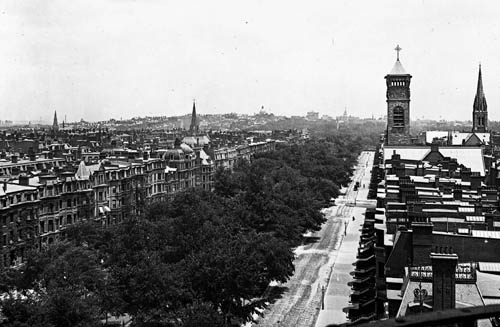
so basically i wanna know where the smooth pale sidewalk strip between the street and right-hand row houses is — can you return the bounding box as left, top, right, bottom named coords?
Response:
left=316, top=152, right=373, bottom=327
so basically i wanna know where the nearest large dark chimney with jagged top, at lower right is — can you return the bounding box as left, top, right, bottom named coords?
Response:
left=430, top=247, right=458, bottom=311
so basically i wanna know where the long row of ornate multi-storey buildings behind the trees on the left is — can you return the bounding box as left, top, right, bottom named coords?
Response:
left=0, top=133, right=275, bottom=269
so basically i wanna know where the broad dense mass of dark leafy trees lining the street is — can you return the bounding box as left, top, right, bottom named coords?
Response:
left=0, top=138, right=361, bottom=327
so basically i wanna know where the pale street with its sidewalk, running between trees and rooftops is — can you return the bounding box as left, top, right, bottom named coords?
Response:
left=254, top=152, right=374, bottom=327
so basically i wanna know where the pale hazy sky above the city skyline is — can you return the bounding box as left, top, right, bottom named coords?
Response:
left=0, top=0, right=500, bottom=121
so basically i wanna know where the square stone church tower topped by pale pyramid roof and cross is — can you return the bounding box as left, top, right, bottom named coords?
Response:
left=385, top=45, right=411, bottom=145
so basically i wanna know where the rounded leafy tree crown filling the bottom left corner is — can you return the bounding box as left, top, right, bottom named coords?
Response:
left=0, top=242, right=105, bottom=327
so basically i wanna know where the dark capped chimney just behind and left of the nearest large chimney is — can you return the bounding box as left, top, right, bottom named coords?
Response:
left=411, top=218, right=434, bottom=265
